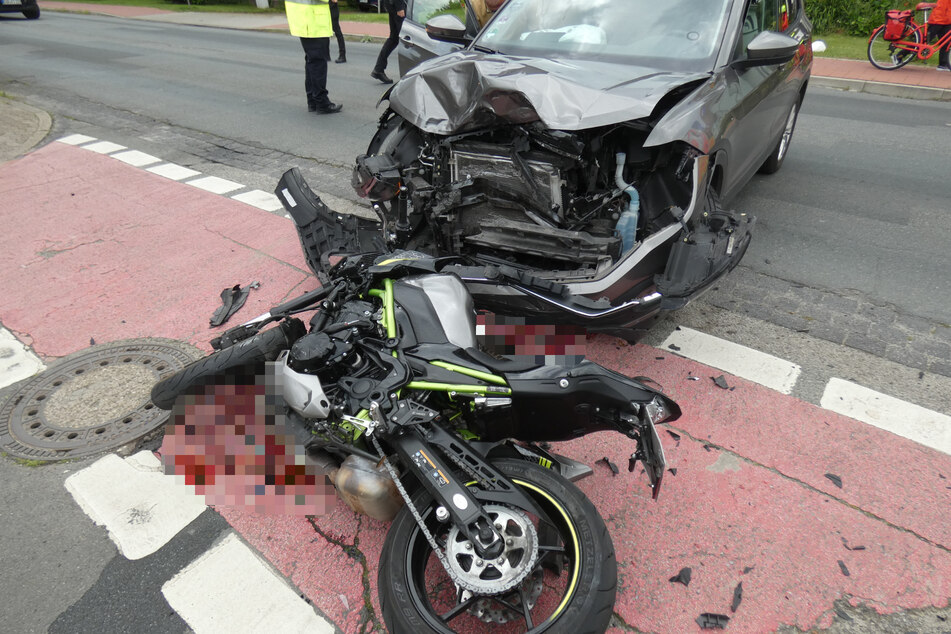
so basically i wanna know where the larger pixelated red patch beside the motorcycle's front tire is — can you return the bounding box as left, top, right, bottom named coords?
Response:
left=161, top=373, right=337, bottom=516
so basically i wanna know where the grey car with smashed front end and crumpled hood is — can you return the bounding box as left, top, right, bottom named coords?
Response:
left=278, top=0, right=812, bottom=340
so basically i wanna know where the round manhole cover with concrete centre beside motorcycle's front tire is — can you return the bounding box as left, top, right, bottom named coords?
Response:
left=0, top=339, right=201, bottom=460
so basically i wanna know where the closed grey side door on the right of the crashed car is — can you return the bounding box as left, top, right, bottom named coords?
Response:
left=721, top=0, right=801, bottom=199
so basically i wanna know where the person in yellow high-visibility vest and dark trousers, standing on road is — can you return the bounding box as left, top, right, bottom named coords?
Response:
left=284, top=0, right=343, bottom=114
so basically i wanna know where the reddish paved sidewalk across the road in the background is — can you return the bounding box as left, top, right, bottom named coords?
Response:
left=40, top=0, right=951, bottom=101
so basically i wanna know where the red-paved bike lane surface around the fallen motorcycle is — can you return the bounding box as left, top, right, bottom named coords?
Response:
left=0, top=143, right=951, bottom=632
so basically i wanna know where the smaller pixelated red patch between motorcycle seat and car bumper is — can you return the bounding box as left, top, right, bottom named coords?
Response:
left=476, top=313, right=587, bottom=366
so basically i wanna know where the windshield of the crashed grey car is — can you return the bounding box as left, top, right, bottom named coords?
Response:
left=474, top=0, right=731, bottom=71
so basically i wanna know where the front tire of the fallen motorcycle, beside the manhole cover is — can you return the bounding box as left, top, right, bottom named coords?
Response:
left=152, top=319, right=304, bottom=410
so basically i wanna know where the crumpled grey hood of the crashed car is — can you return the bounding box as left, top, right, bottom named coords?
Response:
left=389, top=51, right=709, bottom=134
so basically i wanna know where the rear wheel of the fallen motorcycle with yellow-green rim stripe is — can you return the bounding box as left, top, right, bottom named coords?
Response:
left=378, top=459, right=617, bottom=634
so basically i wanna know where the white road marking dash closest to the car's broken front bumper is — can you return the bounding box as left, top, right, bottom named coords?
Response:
left=661, top=327, right=802, bottom=394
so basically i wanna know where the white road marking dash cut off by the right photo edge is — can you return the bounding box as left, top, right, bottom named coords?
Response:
left=819, top=377, right=951, bottom=454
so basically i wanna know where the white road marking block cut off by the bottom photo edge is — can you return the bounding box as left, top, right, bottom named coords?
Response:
left=162, top=534, right=334, bottom=634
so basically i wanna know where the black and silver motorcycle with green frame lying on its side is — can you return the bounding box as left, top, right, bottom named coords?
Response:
left=152, top=246, right=680, bottom=633
